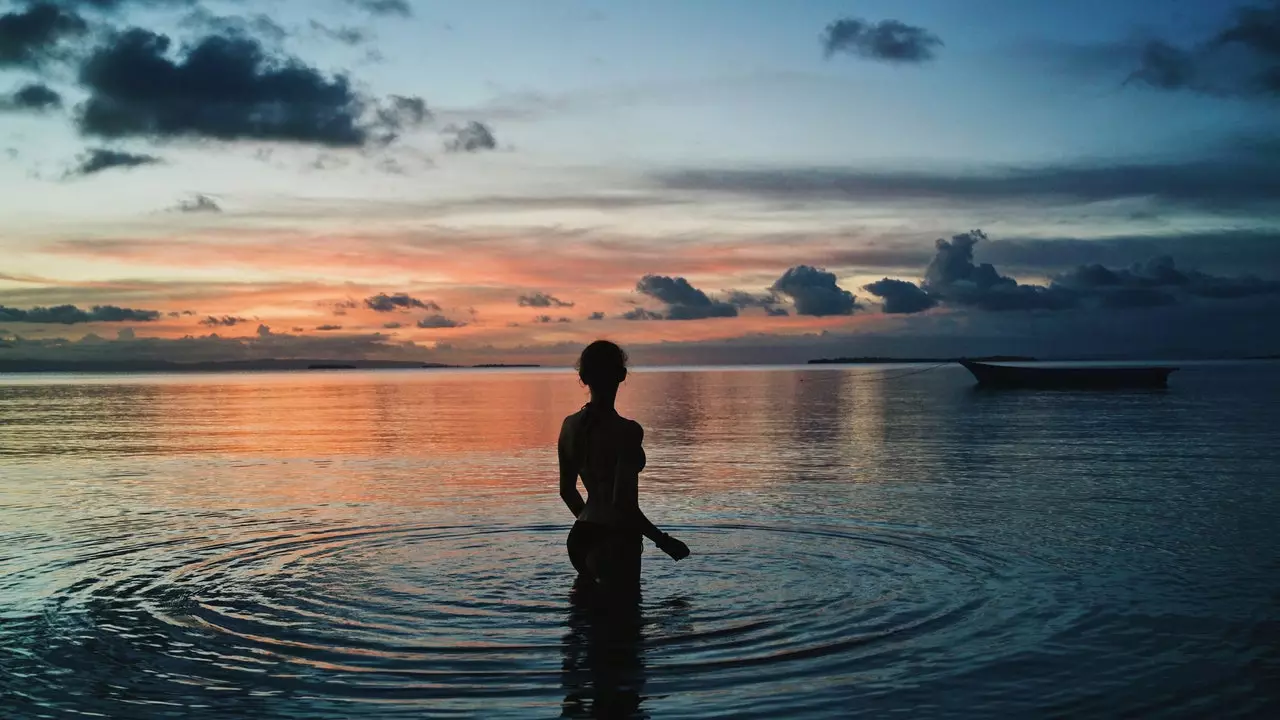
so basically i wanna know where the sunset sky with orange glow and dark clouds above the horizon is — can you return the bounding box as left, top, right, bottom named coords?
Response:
left=0, top=0, right=1280, bottom=364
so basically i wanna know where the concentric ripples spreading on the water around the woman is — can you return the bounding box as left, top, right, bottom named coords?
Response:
left=4, top=512, right=1070, bottom=717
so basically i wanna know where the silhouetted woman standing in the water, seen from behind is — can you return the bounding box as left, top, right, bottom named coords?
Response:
left=559, top=340, right=689, bottom=585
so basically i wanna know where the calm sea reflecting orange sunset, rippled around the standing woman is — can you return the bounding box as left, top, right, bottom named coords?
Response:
left=0, top=363, right=1280, bottom=719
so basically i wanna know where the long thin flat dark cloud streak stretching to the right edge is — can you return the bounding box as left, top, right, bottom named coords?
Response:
left=655, top=152, right=1280, bottom=209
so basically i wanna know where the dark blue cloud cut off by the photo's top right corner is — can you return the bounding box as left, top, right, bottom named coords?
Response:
left=1125, top=3, right=1280, bottom=96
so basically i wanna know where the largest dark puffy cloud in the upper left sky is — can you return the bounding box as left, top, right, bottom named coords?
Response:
left=77, top=28, right=371, bottom=146
